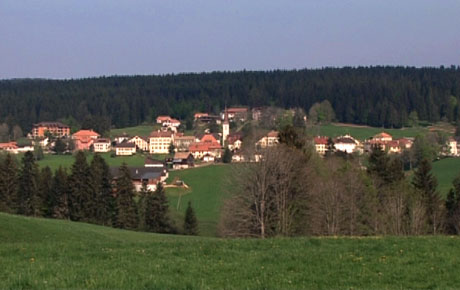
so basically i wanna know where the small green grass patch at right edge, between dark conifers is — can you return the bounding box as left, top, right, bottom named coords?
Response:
left=433, top=158, right=460, bottom=197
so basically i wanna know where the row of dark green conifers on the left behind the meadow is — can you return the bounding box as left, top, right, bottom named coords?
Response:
left=0, top=151, right=198, bottom=234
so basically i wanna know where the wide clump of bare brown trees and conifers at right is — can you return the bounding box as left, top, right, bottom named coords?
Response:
left=220, top=128, right=460, bottom=238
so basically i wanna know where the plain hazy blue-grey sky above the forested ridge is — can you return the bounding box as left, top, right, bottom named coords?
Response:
left=0, top=0, right=460, bottom=79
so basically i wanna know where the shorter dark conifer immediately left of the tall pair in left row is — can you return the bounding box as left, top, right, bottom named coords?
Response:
left=48, top=166, right=70, bottom=219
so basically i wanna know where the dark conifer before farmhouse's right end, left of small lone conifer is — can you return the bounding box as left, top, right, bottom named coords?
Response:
left=145, top=182, right=173, bottom=233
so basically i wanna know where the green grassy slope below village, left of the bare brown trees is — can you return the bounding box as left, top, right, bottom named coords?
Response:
left=166, top=165, right=231, bottom=236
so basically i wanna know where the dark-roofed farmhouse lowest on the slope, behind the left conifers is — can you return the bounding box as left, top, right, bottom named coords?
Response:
left=110, top=167, right=168, bottom=191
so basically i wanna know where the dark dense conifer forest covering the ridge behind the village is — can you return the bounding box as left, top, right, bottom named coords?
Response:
left=0, top=67, right=460, bottom=132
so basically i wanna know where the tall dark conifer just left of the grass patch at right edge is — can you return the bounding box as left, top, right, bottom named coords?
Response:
left=412, top=158, right=443, bottom=234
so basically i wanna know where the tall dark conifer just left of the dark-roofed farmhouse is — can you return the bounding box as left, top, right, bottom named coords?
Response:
left=115, top=163, right=138, bottom=229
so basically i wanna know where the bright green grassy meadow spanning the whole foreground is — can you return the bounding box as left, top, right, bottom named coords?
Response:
left=0, top=214, right=460, bottom=289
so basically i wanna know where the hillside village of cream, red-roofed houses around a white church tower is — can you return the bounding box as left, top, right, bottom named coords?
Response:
left=0, top=107, right=460, bottom=191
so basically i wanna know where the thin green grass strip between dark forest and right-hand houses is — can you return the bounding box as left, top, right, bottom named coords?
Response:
left=309, top=124, right=428, bottom=140
